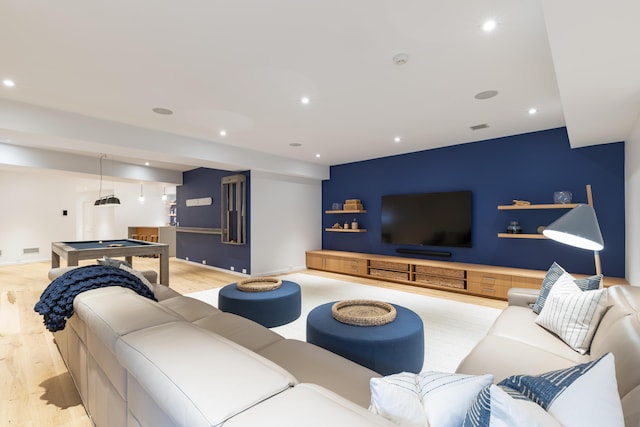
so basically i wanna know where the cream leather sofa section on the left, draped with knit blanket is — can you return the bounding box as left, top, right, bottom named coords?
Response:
left=54, top=284, right=393, bottom=427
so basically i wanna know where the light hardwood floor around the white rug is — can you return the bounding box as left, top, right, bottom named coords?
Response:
left=0, top=257, right=506, bottom=427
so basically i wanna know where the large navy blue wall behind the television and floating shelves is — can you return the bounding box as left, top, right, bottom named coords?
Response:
left=322, top=128, right=625, bottom=277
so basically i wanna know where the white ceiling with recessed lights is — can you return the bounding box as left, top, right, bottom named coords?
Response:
left=0, top=0, right=640, bottom=177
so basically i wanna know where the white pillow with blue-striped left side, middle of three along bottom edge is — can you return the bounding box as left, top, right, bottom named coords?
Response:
left=460, top=384, right=560, bottom=427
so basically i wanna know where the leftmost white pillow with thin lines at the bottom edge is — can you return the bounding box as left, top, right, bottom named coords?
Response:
left=369, top=371, right=493, bottom=427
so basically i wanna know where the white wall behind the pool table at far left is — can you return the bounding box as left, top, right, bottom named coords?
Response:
left=0, top=168, right=175, bottom=265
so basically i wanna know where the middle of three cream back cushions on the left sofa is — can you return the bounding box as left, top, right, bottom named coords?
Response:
left=116, top=321, right=295, bottom=426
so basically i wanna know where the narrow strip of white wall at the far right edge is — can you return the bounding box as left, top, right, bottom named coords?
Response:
left=624, top=120, right=640, bottom=286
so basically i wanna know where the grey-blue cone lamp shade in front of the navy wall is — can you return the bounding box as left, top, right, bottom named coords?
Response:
left=542, top=205, right=604, bottom=251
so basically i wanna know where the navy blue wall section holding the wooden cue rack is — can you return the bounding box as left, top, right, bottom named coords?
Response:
left=176, top=168, right=251, bottom=274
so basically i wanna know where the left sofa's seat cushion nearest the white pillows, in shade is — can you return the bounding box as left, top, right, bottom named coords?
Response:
left=258, top=339, right=380, bottom=408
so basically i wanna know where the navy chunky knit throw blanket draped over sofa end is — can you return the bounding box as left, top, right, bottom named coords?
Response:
left=34, top=265, right=157, bottom=332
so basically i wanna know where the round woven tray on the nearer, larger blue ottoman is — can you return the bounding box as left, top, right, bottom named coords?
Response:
left=331, top=299, right=397, bottom=326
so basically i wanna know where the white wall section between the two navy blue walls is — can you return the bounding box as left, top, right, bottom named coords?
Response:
left=250, top=171, right=322, bottom=276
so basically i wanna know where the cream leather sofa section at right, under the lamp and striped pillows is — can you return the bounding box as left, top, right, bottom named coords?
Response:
left=457, top=285, right=640, bottom=427
